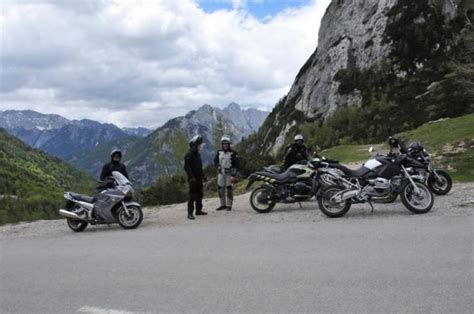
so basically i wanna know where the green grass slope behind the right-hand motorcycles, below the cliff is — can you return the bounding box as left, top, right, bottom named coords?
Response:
left=322, top=114, right=474, bottom=182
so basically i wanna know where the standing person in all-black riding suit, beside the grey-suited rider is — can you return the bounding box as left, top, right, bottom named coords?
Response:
left=184, top=135, right=207, bottom=220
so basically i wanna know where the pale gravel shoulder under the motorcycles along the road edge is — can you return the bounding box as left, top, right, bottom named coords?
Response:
left=0, top=183, right=474, bottom=240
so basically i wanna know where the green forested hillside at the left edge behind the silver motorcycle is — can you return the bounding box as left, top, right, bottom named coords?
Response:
left=0, top=129, right=94, bottom=224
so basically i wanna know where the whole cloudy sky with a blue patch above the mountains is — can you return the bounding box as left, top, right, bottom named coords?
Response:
left=0, top=0, right=330, bottom=127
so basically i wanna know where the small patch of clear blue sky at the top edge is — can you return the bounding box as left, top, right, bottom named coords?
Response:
left=198, top=0, right=311, bottom=19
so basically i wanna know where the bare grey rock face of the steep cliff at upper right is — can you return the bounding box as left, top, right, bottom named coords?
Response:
left=244, top=0, right=465, bottom=155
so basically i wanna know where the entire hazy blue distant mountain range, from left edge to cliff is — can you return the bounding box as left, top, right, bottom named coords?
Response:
left=0, top=103, right=268, bottom=185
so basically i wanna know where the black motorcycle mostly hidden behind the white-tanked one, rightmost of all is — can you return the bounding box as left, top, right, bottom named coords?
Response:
left=407, top=143, right=453, bottom=195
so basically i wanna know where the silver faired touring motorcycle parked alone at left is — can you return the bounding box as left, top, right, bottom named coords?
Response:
left=59, top=171, right=143, bottom=232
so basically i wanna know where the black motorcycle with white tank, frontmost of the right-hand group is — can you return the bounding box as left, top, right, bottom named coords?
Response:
left=317, top=140, right=434, bottom=217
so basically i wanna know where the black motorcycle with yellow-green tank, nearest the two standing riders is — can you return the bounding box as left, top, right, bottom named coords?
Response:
left=246, top=161, right=318, bottom=213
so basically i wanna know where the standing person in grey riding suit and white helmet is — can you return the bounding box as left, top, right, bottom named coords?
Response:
left=214, top=136, right=239, bottom=210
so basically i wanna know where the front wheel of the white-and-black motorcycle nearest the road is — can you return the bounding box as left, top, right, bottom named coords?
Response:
left=400, top=182, right=434, bottom=214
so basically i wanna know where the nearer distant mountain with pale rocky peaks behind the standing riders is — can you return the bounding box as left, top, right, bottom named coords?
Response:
left=66, top=103, right=268, bottom=186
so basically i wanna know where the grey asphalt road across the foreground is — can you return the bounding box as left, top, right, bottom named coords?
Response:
left=0, top=185, right=474, bottom=313
